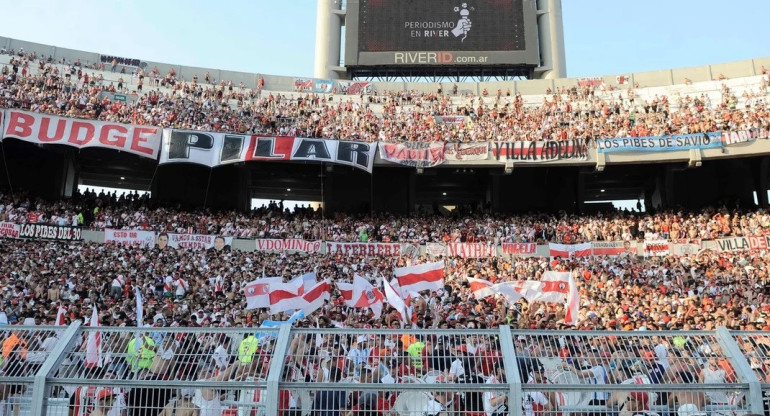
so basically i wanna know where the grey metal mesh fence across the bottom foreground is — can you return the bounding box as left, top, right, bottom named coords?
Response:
left=0, top=322, right=770, bottom=416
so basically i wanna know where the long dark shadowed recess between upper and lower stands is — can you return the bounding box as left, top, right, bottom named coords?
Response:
left=0, top=139, right=770, bottom=214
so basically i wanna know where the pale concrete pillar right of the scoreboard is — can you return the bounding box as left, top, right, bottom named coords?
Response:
left=537, top=0, right=567, bottom=79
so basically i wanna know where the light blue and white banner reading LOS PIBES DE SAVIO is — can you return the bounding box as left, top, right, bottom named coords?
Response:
left=596, top=133, right=722, bottom=153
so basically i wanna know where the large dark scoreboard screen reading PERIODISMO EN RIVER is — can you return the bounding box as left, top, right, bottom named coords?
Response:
left=345, top=0, right=539, bottom=67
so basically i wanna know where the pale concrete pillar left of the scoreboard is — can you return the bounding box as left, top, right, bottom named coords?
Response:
left=313, top=0, right=342, bottom=79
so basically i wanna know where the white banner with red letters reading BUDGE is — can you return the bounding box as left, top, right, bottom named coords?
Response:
left=0, top=110, right=161, bottom=159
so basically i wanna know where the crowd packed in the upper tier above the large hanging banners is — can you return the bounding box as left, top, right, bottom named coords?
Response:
left=0, top=50, right=770, bottom=142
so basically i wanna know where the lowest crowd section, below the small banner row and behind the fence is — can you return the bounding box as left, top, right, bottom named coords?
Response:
left=0, top=223, right=770, bottom=415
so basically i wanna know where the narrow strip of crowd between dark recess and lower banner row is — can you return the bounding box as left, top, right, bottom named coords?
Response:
left=0, top=190, right=770, bottom=244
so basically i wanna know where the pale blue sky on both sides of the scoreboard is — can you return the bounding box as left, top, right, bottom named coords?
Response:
left=0, top=0, right=770, bottom=77
